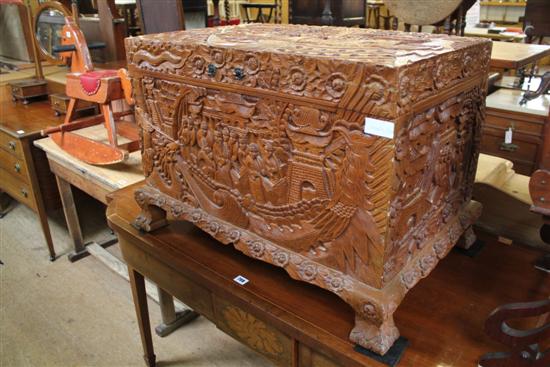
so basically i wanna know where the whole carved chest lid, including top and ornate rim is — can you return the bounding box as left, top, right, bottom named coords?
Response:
left=126, top=24, right=490, bottom=118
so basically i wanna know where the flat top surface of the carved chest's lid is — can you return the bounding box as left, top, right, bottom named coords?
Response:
left=131, top=24, right=484, bottom=67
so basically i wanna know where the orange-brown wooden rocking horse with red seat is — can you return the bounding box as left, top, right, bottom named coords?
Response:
left=42, top=16, right=139, bottom=165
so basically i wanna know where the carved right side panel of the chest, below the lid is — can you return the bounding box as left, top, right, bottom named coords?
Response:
left=384, top=86, right=485, bottom=283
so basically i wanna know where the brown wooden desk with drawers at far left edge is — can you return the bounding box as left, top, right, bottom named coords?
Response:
left=0, top=86, right=62, bottom=261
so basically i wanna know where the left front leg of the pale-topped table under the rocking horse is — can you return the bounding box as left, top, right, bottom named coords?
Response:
left=55, top=175, right=87, bottom=262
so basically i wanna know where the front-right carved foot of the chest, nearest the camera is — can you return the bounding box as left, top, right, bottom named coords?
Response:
left=349, top=316, right=399, bottom=355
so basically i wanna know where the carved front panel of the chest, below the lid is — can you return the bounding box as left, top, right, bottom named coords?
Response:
left=138, top=77, right=394, bottom=288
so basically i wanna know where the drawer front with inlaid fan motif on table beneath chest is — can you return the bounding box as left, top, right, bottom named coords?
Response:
left=213, top=295, right=292, bottom=366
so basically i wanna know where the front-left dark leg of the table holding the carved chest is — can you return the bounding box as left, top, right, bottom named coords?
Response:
left=128, top=267, right=156, bottom=367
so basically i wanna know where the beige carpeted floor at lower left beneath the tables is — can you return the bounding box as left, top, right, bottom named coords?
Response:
left=0, top=195, right=272, bottom=367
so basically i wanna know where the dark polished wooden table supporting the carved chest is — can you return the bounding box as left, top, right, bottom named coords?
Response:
left=107, top=184, right=550, bottom=367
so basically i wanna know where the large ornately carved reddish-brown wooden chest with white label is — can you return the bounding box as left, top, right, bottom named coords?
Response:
left=126, top=24, right=491, bottom=354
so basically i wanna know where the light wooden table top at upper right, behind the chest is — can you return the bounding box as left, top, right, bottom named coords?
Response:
left=491, top=41, right=550, bottom=69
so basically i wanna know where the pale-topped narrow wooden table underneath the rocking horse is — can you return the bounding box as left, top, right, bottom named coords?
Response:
left=34, top=125, right=197, bottom=336
